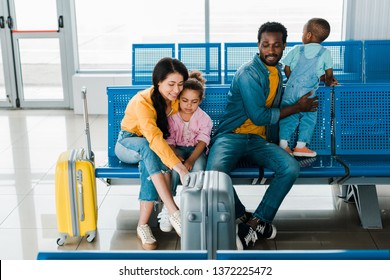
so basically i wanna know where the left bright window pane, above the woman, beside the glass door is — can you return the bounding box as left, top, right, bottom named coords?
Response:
left=76, top=0, right=205, bottom=70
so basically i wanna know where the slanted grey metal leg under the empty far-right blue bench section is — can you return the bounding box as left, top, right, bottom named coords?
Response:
left=345, top=185, right=382, bottom=229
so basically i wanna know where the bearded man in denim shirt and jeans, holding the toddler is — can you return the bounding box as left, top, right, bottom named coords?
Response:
left=206, top=22, right=318, bottom=250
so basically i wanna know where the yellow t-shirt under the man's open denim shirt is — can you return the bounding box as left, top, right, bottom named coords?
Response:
left=233, top=65, right=279, bottom=139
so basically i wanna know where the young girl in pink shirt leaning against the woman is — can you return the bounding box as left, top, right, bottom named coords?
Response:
left=157, top=71, right=213, bottom=232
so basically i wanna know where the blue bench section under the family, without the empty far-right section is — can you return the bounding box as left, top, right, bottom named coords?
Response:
left=96, top=85, right=346, bottom=182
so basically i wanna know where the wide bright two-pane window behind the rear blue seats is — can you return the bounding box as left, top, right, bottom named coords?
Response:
left=75, top=0, right=343, bottom=71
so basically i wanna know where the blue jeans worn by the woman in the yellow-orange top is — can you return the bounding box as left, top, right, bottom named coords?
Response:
left=115, top=130, right=170, bottom=201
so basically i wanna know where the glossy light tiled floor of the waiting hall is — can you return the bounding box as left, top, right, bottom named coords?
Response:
left=0, top=110, right=390, bottom=260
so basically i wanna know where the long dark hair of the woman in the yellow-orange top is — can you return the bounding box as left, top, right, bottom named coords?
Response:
left=152, top=57, right=188, bottom=139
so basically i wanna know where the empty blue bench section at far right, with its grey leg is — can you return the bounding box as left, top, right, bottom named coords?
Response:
left=334, top=84, right=390, bottom=228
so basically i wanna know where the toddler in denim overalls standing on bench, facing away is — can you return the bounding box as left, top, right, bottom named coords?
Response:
left=279, top=18, right=338, bottom=157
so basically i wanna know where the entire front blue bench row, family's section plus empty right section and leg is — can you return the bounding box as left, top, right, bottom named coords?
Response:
left=96, top=84, right=390, bottom=229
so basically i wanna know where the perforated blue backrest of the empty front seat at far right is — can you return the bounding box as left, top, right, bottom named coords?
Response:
left=335, top=84, right=390, bottom=155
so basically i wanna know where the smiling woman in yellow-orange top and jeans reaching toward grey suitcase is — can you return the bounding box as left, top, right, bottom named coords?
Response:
left=115, top=57, right=188, bottom=250
